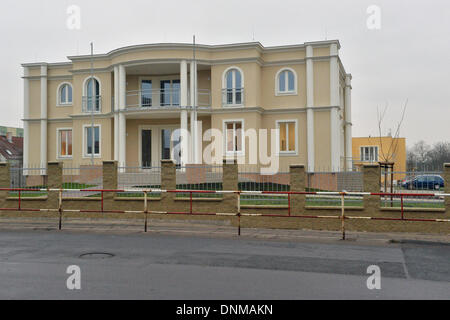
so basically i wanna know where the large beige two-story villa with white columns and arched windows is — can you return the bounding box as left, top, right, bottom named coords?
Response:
left=22, top=41, right=352, bottom=171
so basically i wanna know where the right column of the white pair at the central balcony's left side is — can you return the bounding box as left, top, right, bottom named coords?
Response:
left=119, top=65, right=127, bottom=166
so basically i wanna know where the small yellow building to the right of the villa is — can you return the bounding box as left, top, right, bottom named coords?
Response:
left=352, top=136, right=406, bottom=181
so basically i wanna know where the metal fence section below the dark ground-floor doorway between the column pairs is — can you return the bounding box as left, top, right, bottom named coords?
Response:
left=117, top=164, right=161, bottom=197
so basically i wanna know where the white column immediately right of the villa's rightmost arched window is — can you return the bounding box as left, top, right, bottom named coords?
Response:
left=306, top=46, right=315, bottom=172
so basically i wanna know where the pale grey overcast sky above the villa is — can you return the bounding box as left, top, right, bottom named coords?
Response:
left=0, top=0, right=450, bottom=145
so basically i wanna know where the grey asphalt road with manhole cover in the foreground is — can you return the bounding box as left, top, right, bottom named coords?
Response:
left=0, top=230, right=450, bottom=299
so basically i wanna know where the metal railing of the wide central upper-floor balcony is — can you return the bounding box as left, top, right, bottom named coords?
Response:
left=116, top=89, right=211, bottom=109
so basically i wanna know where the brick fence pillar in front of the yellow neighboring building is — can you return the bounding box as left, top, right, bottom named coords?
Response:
left=363, top=164, right=381, bottom=216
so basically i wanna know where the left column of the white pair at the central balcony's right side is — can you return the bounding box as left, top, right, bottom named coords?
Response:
left=180, top=60, right=189, bottom=165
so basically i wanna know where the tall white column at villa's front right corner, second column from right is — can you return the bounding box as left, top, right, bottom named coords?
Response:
left=330, top=44, right=341, bottom=171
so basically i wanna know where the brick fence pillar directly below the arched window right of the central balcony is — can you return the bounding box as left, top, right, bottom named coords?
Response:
left=222, top=160, right=239, bottom=213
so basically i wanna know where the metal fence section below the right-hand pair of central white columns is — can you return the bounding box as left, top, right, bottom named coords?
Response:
left=176, top=164, right=223, bottom=198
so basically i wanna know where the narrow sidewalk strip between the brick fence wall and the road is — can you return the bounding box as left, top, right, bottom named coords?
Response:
left=0, top=218, right=450, bottom=244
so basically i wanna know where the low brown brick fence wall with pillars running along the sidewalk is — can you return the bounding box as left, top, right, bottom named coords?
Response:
left=0, top=161, right=450, bottom=236
